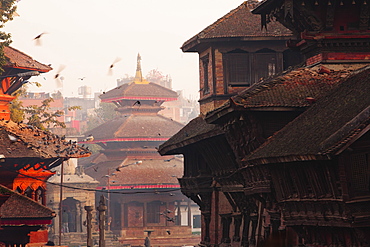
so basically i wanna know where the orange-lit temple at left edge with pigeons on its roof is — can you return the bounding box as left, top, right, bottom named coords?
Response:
left=0, top=47, right=90, bottom=246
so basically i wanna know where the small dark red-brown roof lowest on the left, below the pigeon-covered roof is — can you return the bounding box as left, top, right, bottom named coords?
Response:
left=0, top=184, right=55, bottom=219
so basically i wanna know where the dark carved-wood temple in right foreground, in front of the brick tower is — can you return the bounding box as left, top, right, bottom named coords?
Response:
left=159, top=0, right=370, bottom=247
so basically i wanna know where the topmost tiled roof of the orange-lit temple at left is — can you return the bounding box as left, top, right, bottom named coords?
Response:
left=4, top=46, right=52, bottom=72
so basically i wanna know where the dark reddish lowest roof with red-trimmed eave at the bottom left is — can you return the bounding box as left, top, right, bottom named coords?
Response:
left=0, top=184, right=55, bottom=226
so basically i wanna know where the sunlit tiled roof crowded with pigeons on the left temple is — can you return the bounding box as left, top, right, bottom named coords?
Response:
left=0, top=120, right=90, bottom=159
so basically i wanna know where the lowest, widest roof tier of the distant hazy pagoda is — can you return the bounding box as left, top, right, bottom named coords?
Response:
left=85, top=156, right=183, bottom=187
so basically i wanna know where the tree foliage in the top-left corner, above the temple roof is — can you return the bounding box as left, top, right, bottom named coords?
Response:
left=0, top=0, right=16, bottom=73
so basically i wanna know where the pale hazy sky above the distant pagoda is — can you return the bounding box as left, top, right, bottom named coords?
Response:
left=5, top=0, right=243, bottom=97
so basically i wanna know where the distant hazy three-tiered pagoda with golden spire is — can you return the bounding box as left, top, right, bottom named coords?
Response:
left=82, top=55, right=200, bottom=246
